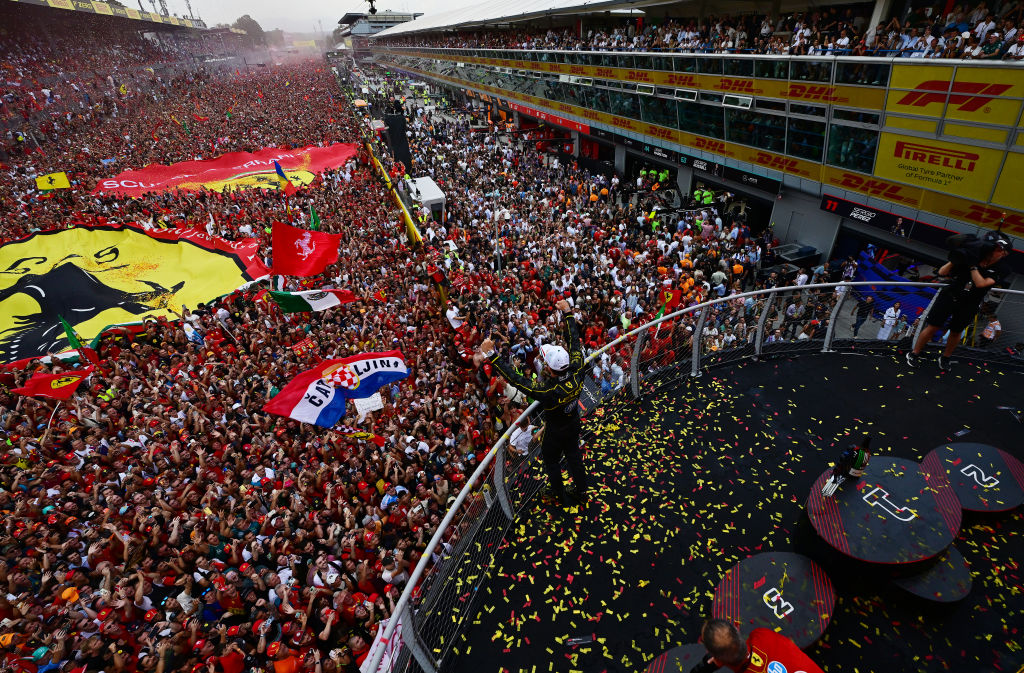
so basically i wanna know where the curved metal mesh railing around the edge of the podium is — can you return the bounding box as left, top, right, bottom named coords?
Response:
left=362, top=282, right=1024, bottom=673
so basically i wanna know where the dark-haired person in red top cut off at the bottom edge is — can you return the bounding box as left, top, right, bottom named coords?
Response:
left=690, top=620, right=824, bottom=673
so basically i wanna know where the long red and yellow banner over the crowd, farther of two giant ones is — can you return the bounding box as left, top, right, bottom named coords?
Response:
left=94, top=142, right=358, bottom=197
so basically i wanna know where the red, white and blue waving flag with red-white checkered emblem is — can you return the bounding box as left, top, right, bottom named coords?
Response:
left=263, top=350, right=409, bottom=427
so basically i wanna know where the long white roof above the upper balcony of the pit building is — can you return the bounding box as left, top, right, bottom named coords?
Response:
left=372, top=0, right=655, bottom=39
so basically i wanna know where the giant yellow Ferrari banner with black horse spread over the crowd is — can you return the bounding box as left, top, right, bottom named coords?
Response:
left=0, top=226, right=268, bottom=363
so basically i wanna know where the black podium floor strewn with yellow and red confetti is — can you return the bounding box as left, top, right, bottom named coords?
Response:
left=444, top=354, right=1024, bottom=673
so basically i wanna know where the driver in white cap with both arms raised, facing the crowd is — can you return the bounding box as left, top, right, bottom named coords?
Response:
left=480, top=299, right=587, bottom=505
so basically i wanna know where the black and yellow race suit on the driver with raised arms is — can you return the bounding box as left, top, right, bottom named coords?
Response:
left=490, top=314, right=587, bottom=493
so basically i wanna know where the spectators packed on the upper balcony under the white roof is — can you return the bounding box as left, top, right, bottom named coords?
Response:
left=378, top=1, right=1024, bottom=60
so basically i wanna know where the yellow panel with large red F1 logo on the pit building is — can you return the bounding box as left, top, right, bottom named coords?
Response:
left=886, top=65, right=1024, bottom=126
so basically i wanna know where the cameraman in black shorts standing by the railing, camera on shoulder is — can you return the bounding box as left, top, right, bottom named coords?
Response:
left=906, top=233, right=1010, bottom=372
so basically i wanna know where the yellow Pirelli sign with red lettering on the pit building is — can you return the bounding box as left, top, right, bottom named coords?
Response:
left=874, top=132, right=1004, bottom=202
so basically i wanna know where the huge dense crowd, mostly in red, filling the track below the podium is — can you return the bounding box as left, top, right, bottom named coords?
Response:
left=0, top=7, right=884, bottom=673
